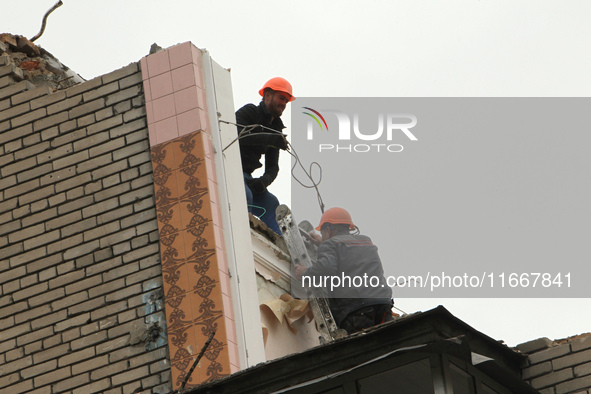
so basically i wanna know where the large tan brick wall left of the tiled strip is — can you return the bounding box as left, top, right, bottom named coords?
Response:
left=0, top=63, right=171, bottom=394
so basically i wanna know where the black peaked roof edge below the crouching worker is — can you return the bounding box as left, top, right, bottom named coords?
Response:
left=189, top=306, right=526, bottom=394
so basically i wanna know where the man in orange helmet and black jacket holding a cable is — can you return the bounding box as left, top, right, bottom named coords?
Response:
left=236, top=77, right=295, bottom=234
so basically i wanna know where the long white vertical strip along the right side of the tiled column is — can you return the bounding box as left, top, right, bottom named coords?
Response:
left=203, top=50, right=266, bottom=369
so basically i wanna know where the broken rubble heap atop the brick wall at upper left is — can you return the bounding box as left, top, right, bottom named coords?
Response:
left=0, top=33, right=85, bottom=91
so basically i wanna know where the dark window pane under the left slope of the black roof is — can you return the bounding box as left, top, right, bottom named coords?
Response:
left=357, top=358, right=435, bottom=394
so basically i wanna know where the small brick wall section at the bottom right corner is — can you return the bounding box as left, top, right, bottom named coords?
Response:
left=517, top=335, right=591, bottom=394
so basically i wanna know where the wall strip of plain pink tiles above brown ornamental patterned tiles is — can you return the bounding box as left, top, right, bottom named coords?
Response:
left=140, top=42, right=239, bottom=389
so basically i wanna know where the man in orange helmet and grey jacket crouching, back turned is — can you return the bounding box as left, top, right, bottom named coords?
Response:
left=295, top=208, right=393, bottom=334
